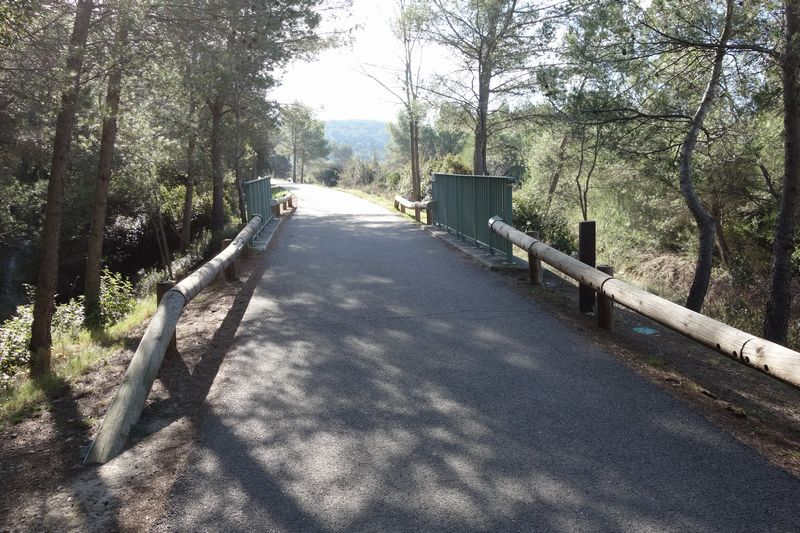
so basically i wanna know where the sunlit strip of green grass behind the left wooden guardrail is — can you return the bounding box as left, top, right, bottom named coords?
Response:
left=0, top=295, right=156, bottom=429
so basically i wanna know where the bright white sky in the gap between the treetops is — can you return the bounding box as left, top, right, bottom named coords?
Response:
left=269, top=0, right=446, bottom=122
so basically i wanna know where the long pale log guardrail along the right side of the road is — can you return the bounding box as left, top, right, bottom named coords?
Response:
left=489, top=217, right=800, bottom=387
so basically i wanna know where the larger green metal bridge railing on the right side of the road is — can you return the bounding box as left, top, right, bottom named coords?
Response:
left=432, top=174, right=514, bottom=261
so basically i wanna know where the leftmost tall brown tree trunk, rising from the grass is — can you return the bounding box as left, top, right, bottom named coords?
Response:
left=30, top=0, right=92, bottom=378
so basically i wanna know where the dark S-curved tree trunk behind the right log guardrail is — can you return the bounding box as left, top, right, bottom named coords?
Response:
left=680, top=0, right=733, bottom=312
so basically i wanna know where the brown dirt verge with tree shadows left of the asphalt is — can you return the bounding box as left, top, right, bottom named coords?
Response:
left=0, top=242, right=276, bottom=531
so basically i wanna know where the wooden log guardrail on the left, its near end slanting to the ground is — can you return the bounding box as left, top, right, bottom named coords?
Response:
left=84, top=215, right=262, bottom=463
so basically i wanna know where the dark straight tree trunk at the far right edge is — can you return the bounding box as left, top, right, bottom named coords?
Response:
left=764, top=0, right=800, bottom=344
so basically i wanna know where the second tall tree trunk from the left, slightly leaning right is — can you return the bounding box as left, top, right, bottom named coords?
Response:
left=84, top=11, right=128, bottom=327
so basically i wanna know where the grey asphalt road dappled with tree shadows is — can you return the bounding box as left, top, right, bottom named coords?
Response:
left=156, top=186, right=800, bottom=532
